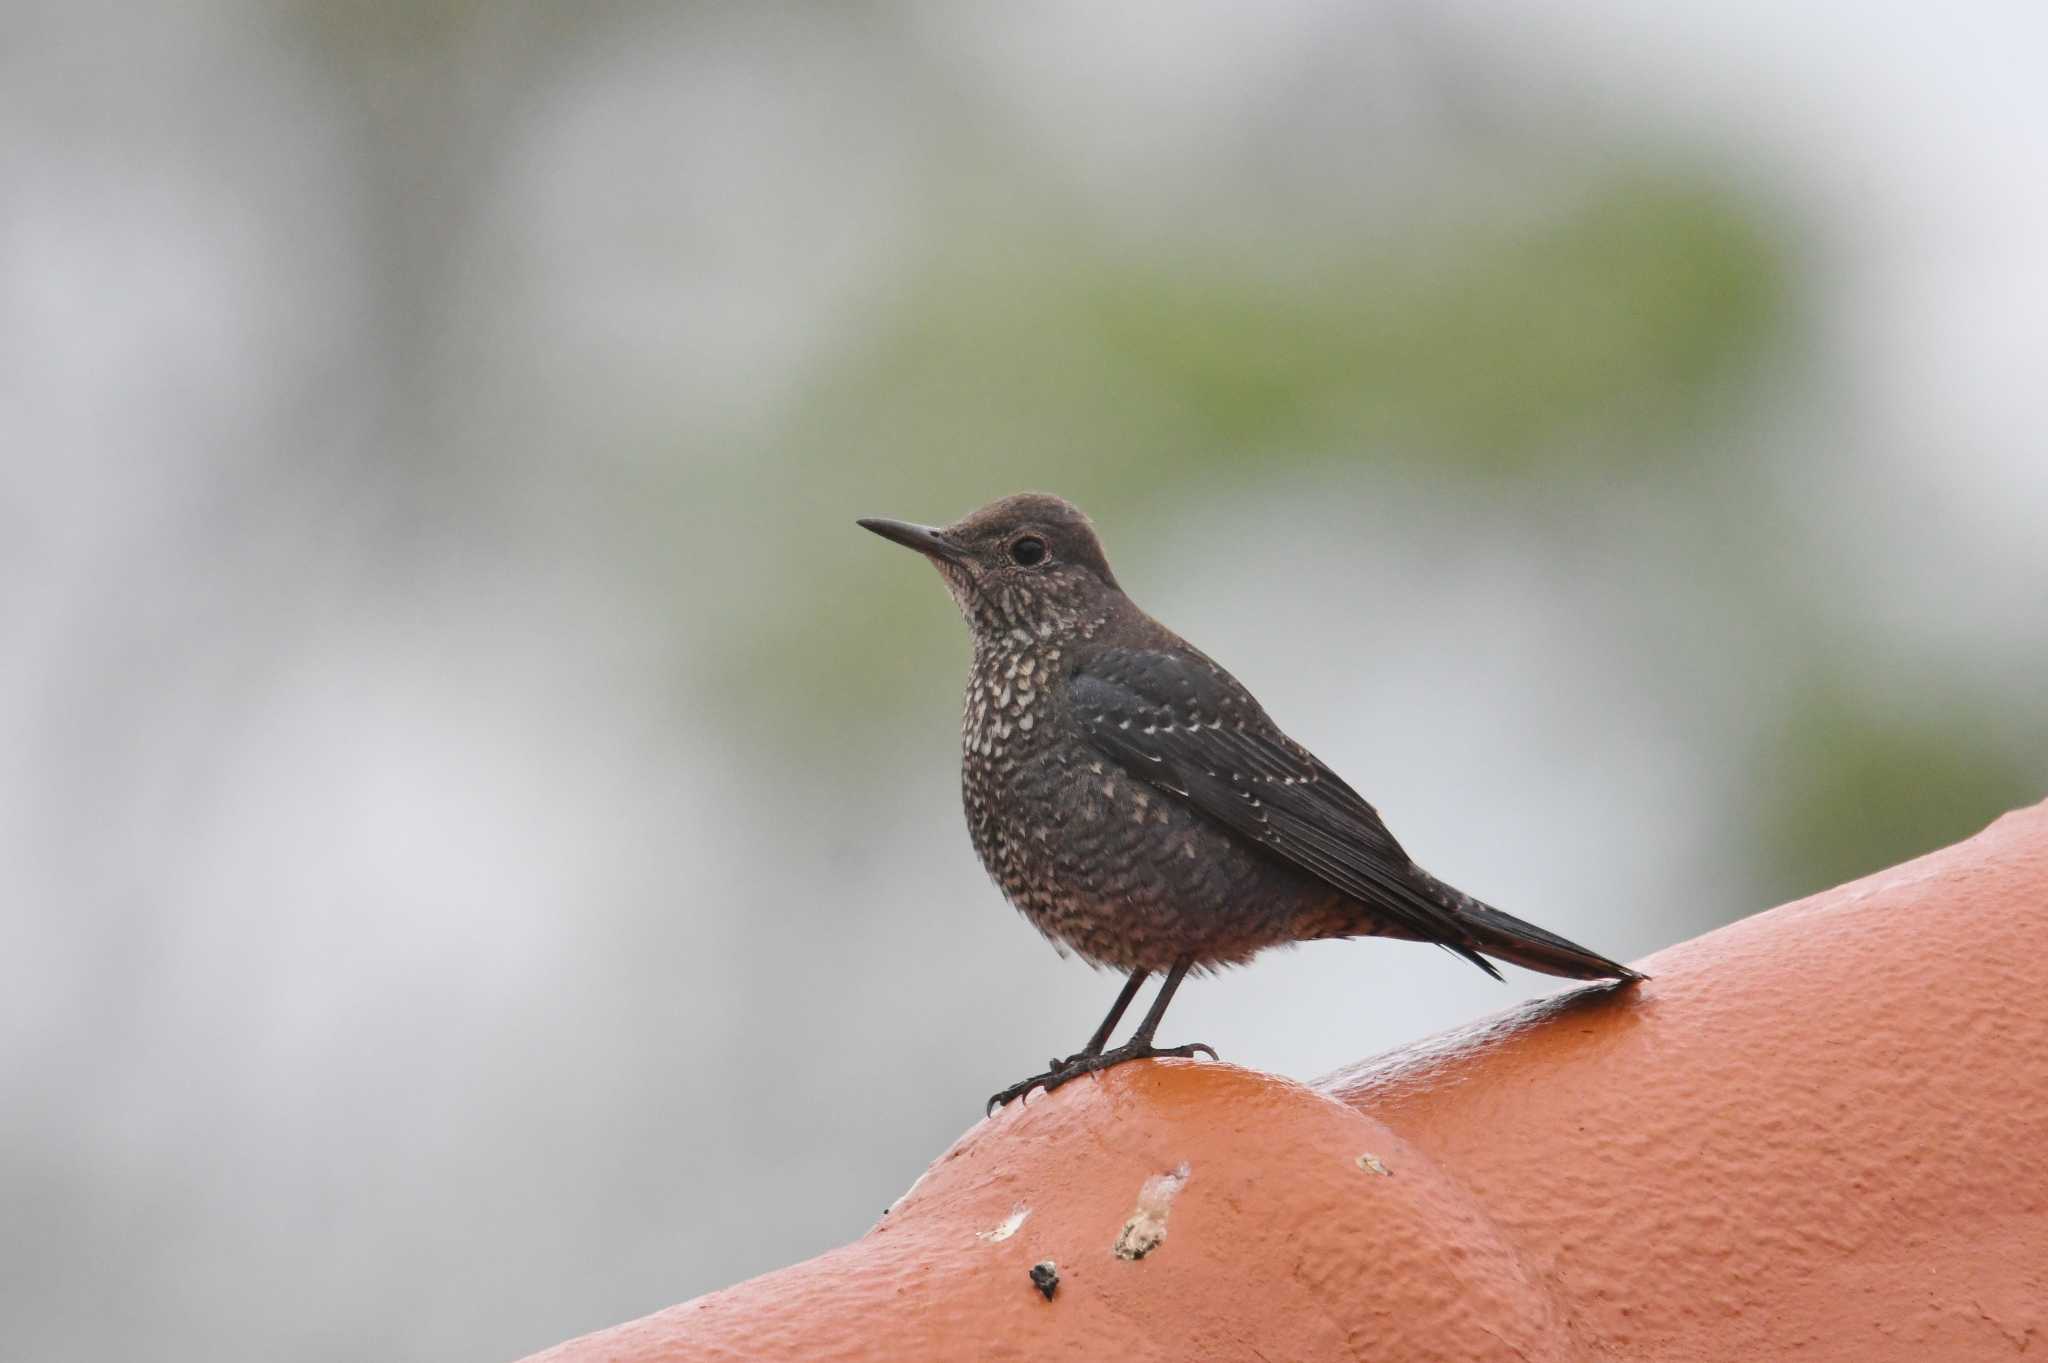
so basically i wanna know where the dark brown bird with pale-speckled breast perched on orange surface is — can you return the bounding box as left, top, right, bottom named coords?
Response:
left=856, top=493, right=1647, bottom=1113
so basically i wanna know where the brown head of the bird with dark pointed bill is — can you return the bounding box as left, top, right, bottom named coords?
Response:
left=860, top=493, right=1122, bottom=639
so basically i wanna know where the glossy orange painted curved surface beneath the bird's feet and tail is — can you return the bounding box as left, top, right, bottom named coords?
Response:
left=539, top=804, right=2048, bottom=1363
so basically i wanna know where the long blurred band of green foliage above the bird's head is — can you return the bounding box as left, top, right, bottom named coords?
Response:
left=801, top=174, right=1784, bottom=489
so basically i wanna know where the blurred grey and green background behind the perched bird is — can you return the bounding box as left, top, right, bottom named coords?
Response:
left=0, top=0, right=2048, bottom=1361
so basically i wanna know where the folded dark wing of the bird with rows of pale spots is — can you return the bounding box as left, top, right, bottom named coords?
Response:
left=1067, top=649, right=1491, bottom=953
